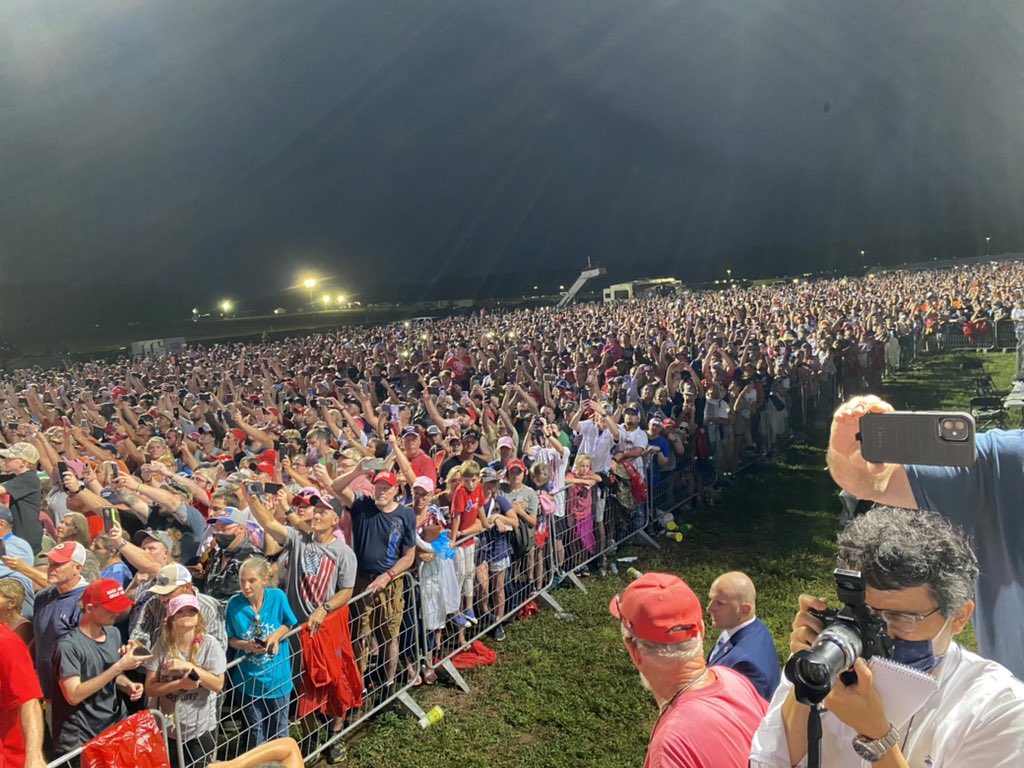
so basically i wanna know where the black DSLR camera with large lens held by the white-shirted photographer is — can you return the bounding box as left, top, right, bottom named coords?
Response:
left=784, top=568, right=893, bottom=705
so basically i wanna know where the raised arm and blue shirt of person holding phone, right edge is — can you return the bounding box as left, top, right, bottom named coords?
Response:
left=828, top=395, right=1024, bottom=679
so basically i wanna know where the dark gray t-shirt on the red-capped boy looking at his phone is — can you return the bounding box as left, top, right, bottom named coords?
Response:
left=53, top=627, right=125, bottom=755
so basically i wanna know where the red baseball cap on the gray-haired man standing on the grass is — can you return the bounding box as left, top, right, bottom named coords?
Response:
left=608, top=573, right=705, bottom=645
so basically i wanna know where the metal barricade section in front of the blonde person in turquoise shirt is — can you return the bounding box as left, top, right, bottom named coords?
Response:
left=148, top=572, right=425, bottom=766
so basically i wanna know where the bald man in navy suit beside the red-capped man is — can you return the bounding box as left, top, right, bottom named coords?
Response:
left=708, top=571, right=779, bottom=700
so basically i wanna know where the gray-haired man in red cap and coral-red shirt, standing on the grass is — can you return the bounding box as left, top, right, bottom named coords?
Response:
left=608, top=573, right=768, bottom=768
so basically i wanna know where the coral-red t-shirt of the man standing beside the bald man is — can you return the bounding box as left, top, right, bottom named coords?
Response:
left=644, top=667, right=768, bottom=768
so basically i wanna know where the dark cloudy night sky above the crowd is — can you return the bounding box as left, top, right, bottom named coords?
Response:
left=0, top=0, right=1024, bottom=309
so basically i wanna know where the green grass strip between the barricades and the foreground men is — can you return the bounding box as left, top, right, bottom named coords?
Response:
left=337, top=353, right=1016, bottom=768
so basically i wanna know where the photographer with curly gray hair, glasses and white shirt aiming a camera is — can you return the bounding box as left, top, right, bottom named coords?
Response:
left=751, top=507, right=1024, bottom=768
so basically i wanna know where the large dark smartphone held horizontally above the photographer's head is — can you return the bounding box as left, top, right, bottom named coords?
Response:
left=858, top=411, right=978, bottom=467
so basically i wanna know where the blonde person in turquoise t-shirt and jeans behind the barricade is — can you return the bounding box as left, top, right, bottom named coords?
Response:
left=225, top=555, right=298, bottom=749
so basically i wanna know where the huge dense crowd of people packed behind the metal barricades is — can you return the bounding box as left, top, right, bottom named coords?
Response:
left=0, top=263, right=1024, bottom=766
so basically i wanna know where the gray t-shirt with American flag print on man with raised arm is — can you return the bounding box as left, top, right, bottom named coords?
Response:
left=285, top=528, right=356, bottom=624
